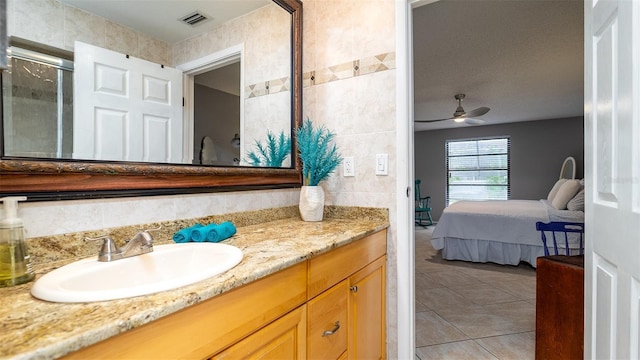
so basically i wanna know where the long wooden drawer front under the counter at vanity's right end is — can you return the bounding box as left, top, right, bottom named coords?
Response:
left=308, top=230, right=387, bottom=299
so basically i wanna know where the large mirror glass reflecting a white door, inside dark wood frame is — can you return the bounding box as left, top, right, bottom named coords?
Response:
left=3, top=0, right=292, bottom=167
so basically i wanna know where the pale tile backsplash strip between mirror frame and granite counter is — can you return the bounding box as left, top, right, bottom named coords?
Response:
left=12, top=189, right=300, bottom=238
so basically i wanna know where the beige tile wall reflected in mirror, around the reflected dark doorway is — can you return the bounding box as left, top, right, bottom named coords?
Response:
left=173, top=3, right=291, bottom=160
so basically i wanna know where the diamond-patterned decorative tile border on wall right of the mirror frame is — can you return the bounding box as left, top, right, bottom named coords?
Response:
left=302, top=52, right=396, bottom=88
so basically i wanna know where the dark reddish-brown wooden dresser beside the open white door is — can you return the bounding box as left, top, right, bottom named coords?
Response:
left=536, top=255, right=584, bottom=359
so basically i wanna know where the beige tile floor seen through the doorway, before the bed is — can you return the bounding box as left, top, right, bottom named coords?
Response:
left=416, top=226, right=536, bottom=360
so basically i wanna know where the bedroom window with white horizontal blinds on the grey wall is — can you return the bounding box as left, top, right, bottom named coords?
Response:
left=445, top=137, right=511, bottom=206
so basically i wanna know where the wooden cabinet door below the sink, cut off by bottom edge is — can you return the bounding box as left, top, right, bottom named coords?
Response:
left=211, top=305, right=307, bottom=360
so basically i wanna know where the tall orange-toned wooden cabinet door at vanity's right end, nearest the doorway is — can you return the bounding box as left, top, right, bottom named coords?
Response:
left=348, top=256, right=386, bottom=359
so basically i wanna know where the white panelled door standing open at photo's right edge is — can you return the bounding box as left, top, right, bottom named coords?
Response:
left=585, top=0, right=640, bottom=359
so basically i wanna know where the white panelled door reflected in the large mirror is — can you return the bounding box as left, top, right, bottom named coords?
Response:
left=73, top=42, right=183, bottom=163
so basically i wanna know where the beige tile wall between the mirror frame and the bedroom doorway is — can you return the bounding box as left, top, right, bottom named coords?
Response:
left=303, top=0, right=398, bottom=358
